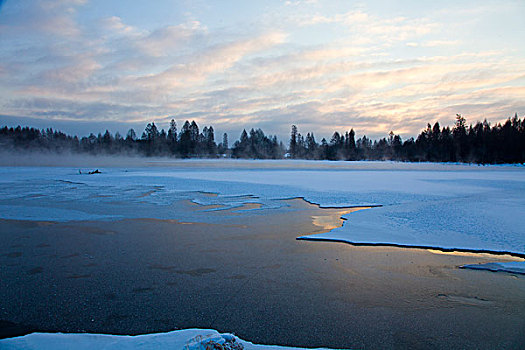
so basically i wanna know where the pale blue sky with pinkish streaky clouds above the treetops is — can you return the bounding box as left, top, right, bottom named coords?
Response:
left=0, top=0, right=525, bottom=140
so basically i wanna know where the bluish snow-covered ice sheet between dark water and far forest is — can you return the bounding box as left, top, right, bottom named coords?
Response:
left=0, top=160, right=525, bottom=272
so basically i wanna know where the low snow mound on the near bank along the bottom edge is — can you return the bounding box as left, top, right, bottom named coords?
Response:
left=0, top=329, right=336, bottom=350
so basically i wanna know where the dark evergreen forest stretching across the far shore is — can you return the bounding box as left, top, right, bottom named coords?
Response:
left=0, top=114, right=525, bottom=164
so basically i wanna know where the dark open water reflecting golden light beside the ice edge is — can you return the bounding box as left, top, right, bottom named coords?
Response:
left=0, top=201, right=525, bottom=349
